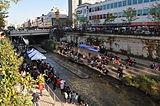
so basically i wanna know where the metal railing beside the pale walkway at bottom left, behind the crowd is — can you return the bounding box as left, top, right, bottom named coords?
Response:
left=44, top=83, right=64, bottom=106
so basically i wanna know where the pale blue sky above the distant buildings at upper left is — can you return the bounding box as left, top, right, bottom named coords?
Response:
left=6, top=0, right=68, bottom=25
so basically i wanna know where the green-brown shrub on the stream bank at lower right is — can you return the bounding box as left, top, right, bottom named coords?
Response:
left=122, top=75, right=160, bottom=100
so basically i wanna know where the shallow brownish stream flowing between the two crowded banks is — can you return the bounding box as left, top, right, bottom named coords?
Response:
left=43, top=53, right=158, bottom=106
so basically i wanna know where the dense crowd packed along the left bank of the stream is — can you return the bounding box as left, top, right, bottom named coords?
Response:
left=14, top=39, right=88, bottom=106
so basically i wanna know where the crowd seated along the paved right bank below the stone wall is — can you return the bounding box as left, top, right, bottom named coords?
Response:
left=59, top=42, right=127, bottom=78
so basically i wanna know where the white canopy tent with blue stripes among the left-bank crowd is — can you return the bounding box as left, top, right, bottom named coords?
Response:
left=27, top=49, right=46, bottom=60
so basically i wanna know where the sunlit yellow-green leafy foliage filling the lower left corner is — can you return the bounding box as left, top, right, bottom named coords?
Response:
left=0, top=37, right=34, bottom=106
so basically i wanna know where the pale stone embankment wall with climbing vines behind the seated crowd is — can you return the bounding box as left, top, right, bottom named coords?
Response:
left=58, top=33, right=160, bottom=59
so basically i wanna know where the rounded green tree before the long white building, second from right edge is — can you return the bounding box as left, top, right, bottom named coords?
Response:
left=122, top=7, right=138, bottom=24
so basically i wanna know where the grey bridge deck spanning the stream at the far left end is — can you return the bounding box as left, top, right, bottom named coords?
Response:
left=9, top=30, right=50, bottom=36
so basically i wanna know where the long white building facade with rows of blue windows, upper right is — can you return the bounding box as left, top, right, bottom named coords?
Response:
left=76, top=0, right=160, bottom=26
